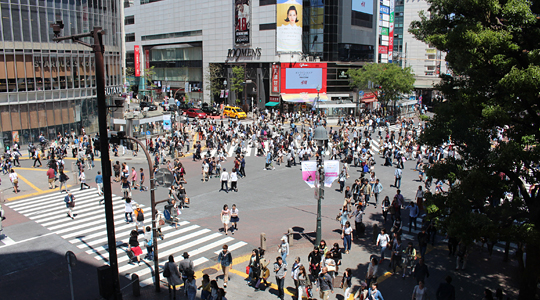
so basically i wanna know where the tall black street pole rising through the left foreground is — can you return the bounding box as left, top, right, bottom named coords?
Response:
left=92, top=27, right=122, bottom=299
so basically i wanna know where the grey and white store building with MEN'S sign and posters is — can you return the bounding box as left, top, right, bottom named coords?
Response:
left=124, top=0, right=377, bottom=114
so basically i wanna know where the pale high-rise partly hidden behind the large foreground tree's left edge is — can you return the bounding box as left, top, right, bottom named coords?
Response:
left=397, top=0, right=447, bottom=95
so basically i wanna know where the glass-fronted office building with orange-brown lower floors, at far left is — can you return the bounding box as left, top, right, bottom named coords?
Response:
left=0, top=0, right=123, bottom=145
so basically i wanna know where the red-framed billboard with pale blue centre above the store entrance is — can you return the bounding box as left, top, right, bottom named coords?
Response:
left=281, top=63, right=327, bottom=94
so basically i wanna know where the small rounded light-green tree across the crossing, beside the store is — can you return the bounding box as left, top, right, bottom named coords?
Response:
left=347, top=63, right=415, bottom=111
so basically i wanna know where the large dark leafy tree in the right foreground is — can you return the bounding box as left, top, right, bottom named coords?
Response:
left=409, top=0, right=540, bottom=299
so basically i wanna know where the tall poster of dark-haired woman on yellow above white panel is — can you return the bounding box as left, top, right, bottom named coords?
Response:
left=276, top=0, right=302, bottom=52
